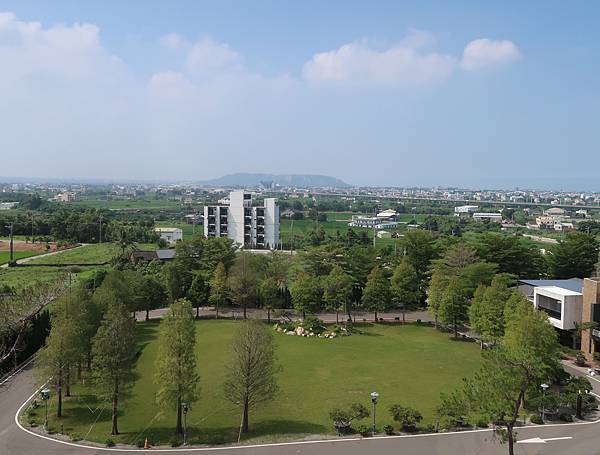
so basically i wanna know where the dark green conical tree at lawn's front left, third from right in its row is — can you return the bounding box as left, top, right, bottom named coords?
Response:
left=92, top=299, right=135, bottom=435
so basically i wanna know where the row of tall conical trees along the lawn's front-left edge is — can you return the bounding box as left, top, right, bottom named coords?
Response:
left=37, top=271, right=278, bottom=435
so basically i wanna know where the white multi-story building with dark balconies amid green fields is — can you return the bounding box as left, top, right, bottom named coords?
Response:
left=204, top=191, right=279, bottom=249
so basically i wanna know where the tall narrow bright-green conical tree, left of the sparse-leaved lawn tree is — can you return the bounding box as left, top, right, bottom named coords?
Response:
left=155, top=299, right=200, bottom=434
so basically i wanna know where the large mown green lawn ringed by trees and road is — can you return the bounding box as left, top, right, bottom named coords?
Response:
left=36, top=321, right=480, bottom=443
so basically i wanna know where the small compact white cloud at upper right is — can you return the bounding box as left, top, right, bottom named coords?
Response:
left=461, top=38, right=521, bottom=71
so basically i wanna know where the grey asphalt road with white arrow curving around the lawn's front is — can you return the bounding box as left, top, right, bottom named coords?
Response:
left=0, top=367, right=600, bottom=455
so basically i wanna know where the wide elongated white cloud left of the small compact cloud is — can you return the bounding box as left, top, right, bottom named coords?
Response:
left=302, top=34, right=458, bottom=85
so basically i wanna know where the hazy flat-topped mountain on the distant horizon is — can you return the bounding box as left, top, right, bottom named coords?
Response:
left=201, top=172, right=350, bottom=188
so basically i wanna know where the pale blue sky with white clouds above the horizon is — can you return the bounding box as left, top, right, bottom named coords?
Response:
left=0, top=0, right=600, bottom=190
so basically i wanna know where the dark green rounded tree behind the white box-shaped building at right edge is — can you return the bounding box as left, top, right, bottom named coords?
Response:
left=549, top=232, right=599, bottom=279
